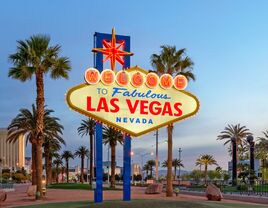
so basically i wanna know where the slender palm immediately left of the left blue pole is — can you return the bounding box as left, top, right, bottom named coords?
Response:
left=77, top=118, right=96, bottom=185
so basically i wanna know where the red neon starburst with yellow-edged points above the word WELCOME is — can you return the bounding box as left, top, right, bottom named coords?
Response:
left=92, top=28, right=133, bottom=70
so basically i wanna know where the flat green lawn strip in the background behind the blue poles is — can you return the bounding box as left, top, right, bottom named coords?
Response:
left=48, top=183, right=121, bottom=190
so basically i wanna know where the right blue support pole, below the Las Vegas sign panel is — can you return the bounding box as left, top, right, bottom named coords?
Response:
left=123, top=135, right=131, bottom=201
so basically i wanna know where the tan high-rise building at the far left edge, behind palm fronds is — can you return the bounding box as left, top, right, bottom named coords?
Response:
left=0, top=128, right=25, bottom=169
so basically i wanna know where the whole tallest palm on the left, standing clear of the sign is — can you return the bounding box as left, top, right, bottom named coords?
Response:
left=8, top=35, right=70, bottom=198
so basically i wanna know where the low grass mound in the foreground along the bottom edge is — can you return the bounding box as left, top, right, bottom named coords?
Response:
left=16, top=200, right=267, bottom=208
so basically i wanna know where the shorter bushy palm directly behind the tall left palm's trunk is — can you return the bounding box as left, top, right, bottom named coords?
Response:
left=7, top=105, right=62, bottom=185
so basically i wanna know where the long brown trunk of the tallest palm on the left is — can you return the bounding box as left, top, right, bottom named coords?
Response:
left=36, top=68, right=45, bottom=198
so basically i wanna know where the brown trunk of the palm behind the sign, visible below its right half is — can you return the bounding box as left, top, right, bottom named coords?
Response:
left=166, top=125, right=173, bottom=197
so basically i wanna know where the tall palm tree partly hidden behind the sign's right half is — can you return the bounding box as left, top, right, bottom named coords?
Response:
left=151, top=45, right=195, bottom=196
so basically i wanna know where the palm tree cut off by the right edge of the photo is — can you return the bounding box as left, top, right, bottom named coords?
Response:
left=255, top=131, right=268, bottom=180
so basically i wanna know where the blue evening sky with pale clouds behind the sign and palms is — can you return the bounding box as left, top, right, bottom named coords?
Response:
left=0, top=0, right=268, bottom=169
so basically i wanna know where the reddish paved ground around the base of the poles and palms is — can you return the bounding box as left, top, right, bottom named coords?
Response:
left=1, top=184, right=266, bottom=207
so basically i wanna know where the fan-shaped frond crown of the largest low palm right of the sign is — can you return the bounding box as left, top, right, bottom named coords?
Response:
left=217, top=124, right=252, bottom=158
